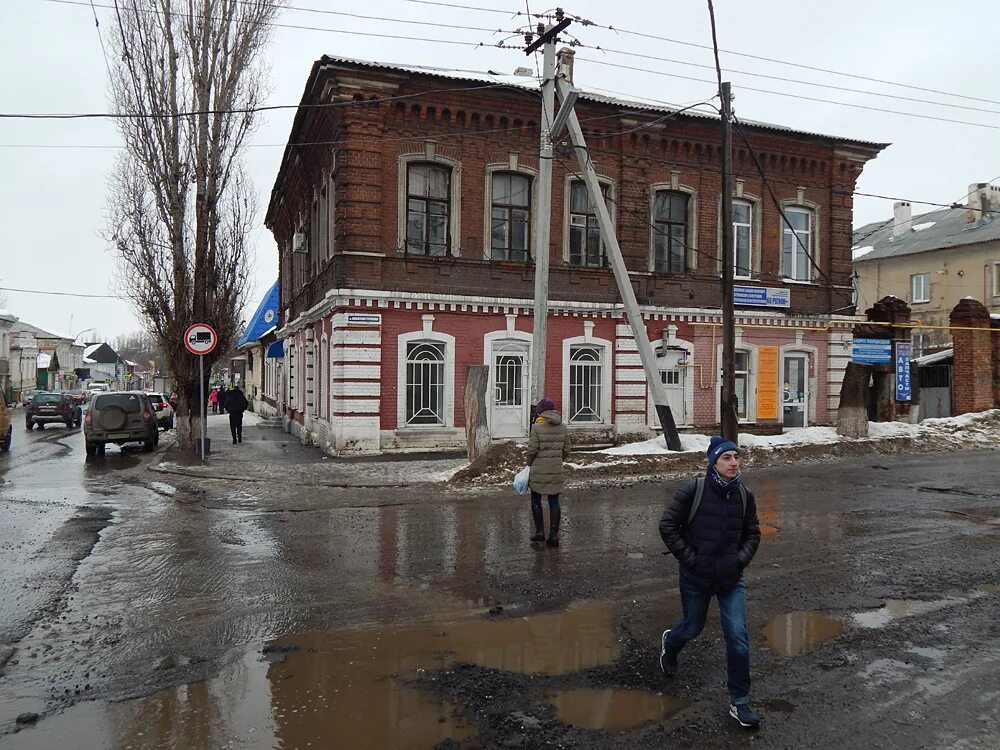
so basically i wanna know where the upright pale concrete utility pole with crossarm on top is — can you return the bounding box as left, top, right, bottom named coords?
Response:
left=524, top=18, right=572, bottom=419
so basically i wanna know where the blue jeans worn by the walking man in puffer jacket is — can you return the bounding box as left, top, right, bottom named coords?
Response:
left=667, top=573, right=750, bottom=704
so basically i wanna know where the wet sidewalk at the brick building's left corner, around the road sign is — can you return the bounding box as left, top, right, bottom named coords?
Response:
left=150, top=412, right=468, bottom=488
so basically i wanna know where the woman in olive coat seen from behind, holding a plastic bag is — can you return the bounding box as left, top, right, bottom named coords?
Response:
left=526, top=398, right=569, bottom=547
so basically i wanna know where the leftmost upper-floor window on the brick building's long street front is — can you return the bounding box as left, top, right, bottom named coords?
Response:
left=406, top=162, right=451, bottom=256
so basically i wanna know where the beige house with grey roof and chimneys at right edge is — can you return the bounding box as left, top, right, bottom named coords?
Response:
left=853, top=183, right=1000, bottom=357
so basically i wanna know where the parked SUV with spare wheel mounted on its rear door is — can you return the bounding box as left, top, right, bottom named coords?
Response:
left=83, top=391, right=160, bottom=456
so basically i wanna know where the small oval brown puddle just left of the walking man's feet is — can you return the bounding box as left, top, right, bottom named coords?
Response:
left=545, top=689, right=687, bottom=732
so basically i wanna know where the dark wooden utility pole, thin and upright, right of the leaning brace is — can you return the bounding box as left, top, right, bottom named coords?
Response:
left=719, top=81, right=740, bottom=443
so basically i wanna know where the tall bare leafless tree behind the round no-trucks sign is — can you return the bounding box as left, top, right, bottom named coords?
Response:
left=108, top=0, right=280, bottom=449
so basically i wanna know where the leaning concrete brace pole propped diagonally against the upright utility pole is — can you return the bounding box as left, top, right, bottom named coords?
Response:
left=553, top=78, right=681, bottom=451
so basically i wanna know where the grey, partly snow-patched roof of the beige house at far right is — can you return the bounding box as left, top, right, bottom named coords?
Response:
left=854, top=208, right=1000, bottom=263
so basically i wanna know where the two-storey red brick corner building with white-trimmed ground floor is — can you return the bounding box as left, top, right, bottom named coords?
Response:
left=266, top=54, right=885, bottom=452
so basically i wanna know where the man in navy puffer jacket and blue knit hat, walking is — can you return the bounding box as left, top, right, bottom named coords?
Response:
left=660, top=436, right=760, bottom=727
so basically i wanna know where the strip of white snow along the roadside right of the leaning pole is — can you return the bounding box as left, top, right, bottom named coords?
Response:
left=597, top=411, right=996, bottom=456
